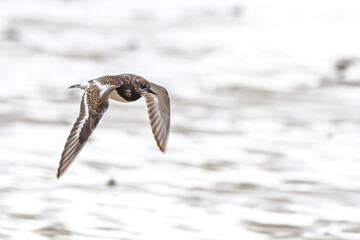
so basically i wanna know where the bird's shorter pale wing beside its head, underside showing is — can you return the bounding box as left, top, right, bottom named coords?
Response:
left=143, top=83, right=170, bottom=152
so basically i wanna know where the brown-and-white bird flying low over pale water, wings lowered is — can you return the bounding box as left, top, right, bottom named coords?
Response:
left=57, top=73, right=170, bottom=178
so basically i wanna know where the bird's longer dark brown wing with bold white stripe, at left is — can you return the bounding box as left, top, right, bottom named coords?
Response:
left=57, top=82, right=116, bottom=178
